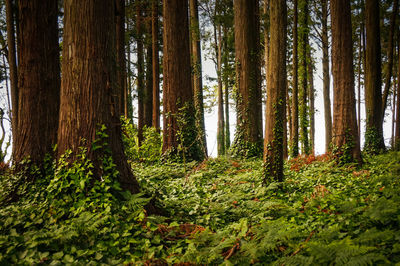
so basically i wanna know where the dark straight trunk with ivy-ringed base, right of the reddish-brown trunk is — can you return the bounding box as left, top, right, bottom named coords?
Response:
left=365, top=0, right=385, bottom=153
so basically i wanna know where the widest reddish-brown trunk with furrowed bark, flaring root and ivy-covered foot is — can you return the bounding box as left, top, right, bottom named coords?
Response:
left=58, top=0, right=139, bottom=193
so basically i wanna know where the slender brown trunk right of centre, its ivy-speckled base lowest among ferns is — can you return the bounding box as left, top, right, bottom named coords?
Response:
left=264, top=0, right=287, bottom=182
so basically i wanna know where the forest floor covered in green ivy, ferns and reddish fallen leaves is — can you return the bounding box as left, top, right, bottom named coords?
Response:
left=0, top=152, right=400, bottom=265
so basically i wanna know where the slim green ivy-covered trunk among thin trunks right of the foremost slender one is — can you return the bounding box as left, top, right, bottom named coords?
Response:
left=299, top=0, right=310, bottom=154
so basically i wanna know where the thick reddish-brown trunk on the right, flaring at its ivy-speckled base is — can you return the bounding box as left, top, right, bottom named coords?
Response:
left=330, top=0, right=362, bottom=163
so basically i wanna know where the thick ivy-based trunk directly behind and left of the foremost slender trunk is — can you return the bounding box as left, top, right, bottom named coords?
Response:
left=232, top=0, right=262, bottom=157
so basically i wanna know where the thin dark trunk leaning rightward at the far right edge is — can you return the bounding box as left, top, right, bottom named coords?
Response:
left=380, top=0, right=399, bottom=119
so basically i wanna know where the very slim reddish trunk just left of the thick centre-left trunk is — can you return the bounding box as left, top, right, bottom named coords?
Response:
left=151, top=0, right=160, bottom=130
